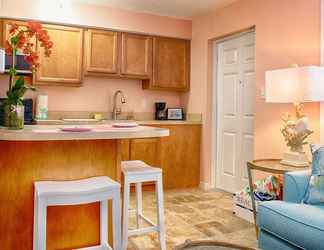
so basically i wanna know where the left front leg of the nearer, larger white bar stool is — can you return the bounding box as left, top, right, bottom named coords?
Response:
left=34, top=198, right=47, bottom=250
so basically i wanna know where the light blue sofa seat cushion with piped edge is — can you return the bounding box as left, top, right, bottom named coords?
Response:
left=258, top=201, right=324, bottom=249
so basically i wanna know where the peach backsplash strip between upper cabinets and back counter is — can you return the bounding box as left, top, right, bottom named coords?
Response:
left=0, top=75, right=180, bottom=114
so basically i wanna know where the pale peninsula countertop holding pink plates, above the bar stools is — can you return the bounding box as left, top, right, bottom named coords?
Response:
left=0, top=124, right=169, bottom=141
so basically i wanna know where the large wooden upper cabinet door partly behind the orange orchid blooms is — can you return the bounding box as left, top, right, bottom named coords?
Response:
left=36, top=25, right=83, bottom=86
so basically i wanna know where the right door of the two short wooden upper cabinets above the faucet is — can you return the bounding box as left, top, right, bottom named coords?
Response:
left=121, top=33, right=152, bottom=79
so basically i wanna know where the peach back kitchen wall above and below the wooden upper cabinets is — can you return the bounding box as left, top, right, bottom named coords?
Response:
left=0, top=0, right=191, bottom=112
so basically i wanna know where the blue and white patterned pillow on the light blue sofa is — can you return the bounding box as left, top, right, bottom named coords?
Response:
left=303, top=144, right=324, bottom=205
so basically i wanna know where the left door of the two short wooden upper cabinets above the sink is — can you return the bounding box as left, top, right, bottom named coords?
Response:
left=85, top=30, right=119, bottom=74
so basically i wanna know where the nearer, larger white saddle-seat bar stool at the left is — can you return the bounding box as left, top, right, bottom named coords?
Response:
left=33, top=176, right=121, bottom=250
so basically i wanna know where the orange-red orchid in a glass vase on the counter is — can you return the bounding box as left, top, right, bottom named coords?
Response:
left=4, top=21, right=53, bottom=129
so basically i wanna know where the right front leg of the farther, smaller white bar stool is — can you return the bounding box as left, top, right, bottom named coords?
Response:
left=155, top=174, right=166, bottom=250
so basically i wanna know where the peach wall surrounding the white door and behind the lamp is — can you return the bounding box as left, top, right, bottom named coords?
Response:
left=181, top=0, right=320, bottom=187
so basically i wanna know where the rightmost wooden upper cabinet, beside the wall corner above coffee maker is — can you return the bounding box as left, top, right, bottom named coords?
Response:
left=143, top=37, right=190, bottom=91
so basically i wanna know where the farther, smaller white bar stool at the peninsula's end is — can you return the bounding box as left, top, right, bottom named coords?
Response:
left=121, top=161, right=166, bottom=250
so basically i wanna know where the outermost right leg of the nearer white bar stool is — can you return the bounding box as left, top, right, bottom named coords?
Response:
left=112, top=192, right=122, bottom=250
